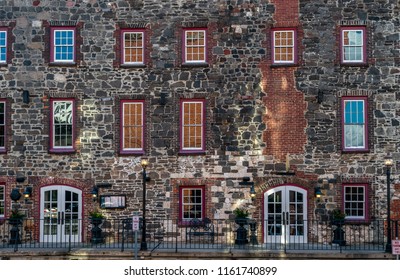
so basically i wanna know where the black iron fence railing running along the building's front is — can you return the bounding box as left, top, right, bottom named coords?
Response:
left=0, top=218, right=400, bottom=252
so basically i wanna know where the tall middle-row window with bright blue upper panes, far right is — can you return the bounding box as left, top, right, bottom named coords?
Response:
left=342, top=97, right=368, bottom=151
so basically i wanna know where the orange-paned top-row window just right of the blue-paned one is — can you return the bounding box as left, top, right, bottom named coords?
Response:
left=121, top=30, right=144, bottom=65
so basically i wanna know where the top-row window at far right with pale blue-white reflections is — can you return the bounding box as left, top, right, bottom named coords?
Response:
left=340, top=27, right=367, bottom=63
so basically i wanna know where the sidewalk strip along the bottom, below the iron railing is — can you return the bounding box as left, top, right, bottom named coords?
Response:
left=0, top=248, right=396, bottom=260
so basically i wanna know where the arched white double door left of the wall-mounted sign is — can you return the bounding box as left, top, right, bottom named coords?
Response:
left=40, top=185, right=82, bottom=242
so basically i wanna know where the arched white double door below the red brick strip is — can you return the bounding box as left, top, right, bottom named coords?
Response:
left=264, top=186, right=307, bottom=244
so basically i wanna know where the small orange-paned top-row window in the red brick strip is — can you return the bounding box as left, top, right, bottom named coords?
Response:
left=272, top=30, right=296, bottom=64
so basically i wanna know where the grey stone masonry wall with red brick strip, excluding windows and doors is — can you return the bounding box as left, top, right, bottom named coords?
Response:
left=0, top=0, right=400, bottom=238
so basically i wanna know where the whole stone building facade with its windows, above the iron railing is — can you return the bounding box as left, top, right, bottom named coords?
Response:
left=0, top=0, right=400, bottom=242
